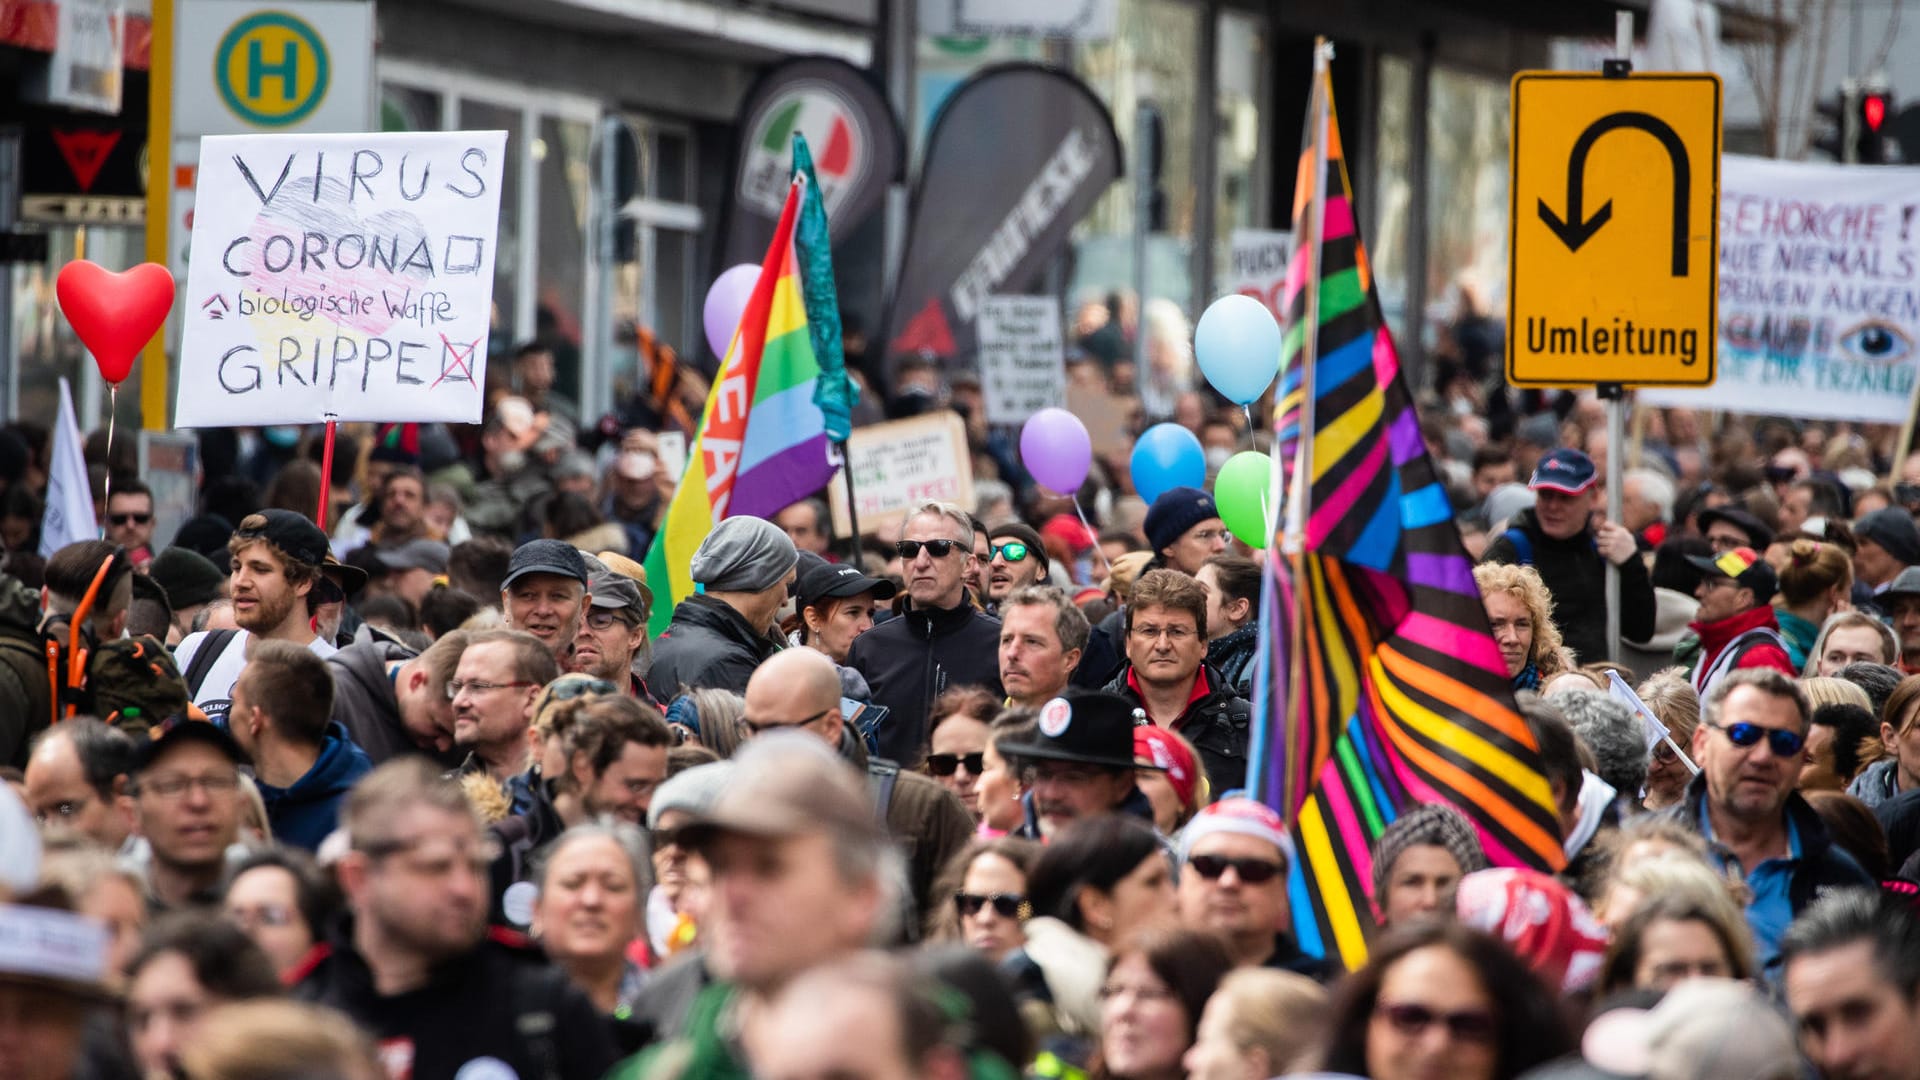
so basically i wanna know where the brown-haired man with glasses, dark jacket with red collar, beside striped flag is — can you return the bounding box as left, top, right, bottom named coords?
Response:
left=1106, top=571, right=1254, bottom=792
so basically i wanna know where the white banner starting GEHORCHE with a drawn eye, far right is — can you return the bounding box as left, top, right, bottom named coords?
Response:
left=1640, top=154, right=1920, bottom=423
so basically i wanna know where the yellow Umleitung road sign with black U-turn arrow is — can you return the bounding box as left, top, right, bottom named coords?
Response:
left=1507, top=71, right=1720, bottom=386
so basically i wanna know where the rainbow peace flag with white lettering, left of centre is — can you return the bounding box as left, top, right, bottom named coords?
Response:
left=645, top=175, right=835, bottom=636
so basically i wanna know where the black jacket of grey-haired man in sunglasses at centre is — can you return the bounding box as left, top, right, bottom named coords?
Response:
left=852, top=600, right=1006, bottom=769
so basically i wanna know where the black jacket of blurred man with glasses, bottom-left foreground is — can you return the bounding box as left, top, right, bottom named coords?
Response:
left=294, top=914, right=616, bottom=1080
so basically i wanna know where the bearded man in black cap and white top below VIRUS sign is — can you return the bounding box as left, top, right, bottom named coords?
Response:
left=175, top=509, right=340, bottom=723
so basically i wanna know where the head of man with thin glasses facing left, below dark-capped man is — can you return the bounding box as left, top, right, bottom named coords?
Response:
left=447, top=630, right=561, bottom=780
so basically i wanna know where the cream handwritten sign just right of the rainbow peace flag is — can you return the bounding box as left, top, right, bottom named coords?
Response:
left=828, top=409, right=973, bottom=536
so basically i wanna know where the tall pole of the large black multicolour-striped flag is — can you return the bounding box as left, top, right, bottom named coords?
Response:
left=1284, top=38, right=1332, bottom=813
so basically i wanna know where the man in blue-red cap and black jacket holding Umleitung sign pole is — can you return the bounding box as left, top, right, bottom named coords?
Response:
left=1480, top=448, right=1657, bottom=663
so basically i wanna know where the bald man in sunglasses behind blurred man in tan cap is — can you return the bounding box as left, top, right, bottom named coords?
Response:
left=741, top=650, right=973, bottom=913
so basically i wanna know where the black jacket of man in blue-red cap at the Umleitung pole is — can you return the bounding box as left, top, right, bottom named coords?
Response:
left=1480, top=509, right=1657, bottom=663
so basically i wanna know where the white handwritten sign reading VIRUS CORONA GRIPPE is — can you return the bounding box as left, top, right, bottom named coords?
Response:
left=175, top=131, right=507, bottom=427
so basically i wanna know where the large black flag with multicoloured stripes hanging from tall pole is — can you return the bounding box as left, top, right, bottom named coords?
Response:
left=1250, top=44, right=1565, bottom=969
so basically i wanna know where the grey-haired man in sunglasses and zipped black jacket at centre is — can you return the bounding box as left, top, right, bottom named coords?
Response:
left=847, top=502, right=1004, bottom=761
